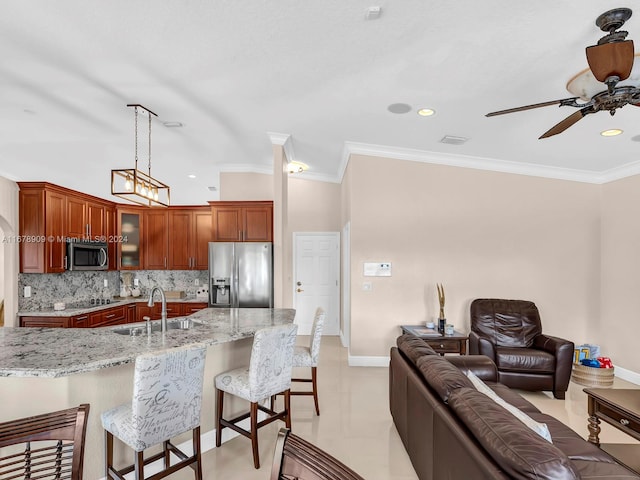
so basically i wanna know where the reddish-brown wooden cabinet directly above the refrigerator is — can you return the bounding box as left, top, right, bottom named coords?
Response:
left=209, top=201, right=273, bottom=242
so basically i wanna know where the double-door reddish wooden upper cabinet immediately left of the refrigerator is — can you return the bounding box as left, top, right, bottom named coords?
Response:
left=169, top=207, right=213, bottom=270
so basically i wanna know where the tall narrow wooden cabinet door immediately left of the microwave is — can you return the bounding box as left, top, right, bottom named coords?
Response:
left=45, top=191, right=67, bottom=273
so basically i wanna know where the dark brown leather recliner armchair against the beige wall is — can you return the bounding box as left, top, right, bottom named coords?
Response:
left=469, top=298, right=574, bottom=399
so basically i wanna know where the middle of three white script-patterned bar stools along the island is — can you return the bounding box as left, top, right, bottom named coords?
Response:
left=215, top=324, right=298, bottom=468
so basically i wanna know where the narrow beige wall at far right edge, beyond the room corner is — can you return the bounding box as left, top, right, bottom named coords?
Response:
left=600, top=176, right=640, bottom=375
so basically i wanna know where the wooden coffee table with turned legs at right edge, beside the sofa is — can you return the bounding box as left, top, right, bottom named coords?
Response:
left=583, top=388, right=640, bottom=473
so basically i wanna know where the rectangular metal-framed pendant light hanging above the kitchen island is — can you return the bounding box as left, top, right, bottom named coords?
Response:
left=111, top=103, right=170, bottom=207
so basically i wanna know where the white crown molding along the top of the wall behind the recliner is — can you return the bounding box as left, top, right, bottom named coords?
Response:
left=338, top=142, right=640, bottom=184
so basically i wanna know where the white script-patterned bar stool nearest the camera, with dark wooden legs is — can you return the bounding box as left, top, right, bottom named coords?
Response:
left=101, top=345, right=206, bottom=480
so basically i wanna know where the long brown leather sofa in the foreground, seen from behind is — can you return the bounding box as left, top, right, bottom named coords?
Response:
left=389, top=334, right=640, bottom=480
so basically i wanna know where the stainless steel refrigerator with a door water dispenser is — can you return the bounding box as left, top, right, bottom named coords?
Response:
left=209, top=242, right=273, bottom=308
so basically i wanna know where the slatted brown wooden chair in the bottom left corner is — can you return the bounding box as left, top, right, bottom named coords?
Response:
left=0, top=403, right=89, bottom=480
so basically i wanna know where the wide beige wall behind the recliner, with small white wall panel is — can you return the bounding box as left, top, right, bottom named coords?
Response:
left=348, top=156, right=601, bottom=356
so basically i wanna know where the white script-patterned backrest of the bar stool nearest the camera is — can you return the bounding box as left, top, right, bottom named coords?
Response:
left=131, top=345, right=206, bottom=448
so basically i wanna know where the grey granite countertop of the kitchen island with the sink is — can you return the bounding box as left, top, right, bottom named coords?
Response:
left=0, top=308, right=295, bottom=377
